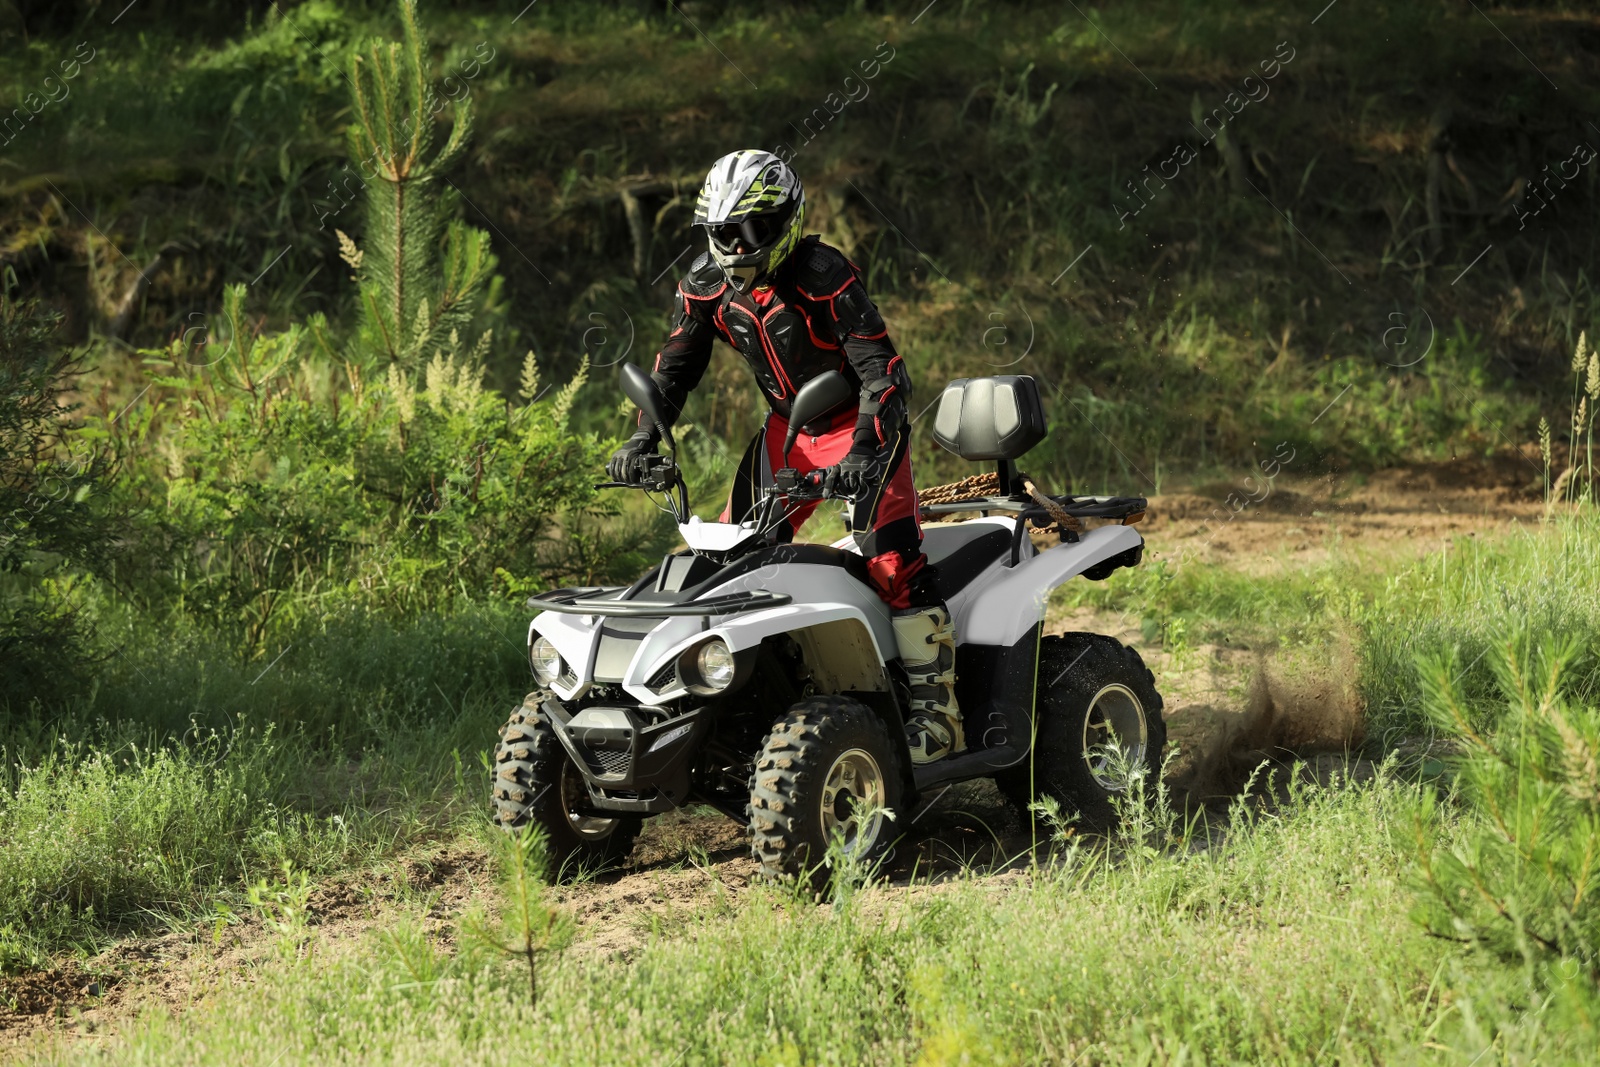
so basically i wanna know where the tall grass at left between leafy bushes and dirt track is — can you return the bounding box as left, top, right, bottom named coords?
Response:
left=0, top=608, right=526, bottom=969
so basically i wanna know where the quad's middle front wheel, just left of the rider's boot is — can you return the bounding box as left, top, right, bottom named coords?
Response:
left=750, top=696, right=902, bottom=878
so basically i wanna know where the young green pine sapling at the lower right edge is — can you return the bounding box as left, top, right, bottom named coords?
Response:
left=1418, top=632, right=1600, bottom=981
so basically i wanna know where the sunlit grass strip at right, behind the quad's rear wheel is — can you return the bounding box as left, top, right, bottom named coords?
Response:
left=1056, top=507, right=1600, bottom=752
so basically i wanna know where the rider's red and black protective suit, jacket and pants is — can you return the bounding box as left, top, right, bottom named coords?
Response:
left=654, top=235, right=931, bottom=609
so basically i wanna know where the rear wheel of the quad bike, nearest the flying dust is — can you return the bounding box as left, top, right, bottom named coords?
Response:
left=997, top=633, right=1166, bottom=830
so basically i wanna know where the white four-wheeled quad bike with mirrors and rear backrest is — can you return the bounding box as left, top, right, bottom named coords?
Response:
left=493, top=365, right=1166, bottom=877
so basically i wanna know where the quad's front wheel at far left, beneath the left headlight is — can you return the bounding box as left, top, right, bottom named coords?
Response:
left=494, top=694, right=643, bottom=875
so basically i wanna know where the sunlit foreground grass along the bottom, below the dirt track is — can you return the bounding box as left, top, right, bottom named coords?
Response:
left=15, top=764, right=1597, bottom=1064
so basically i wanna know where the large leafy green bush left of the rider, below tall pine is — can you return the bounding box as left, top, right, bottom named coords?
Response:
left=114, top=286, right=605, bottom=648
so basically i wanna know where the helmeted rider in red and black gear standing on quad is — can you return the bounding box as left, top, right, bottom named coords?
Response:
left=606, top=150, right=966, bottom=763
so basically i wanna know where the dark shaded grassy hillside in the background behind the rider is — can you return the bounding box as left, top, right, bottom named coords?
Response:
left=0, top=0, right=1600, bottom=490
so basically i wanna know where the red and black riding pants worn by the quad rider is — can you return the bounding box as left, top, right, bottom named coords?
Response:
left=722, top=410, right=926, bottom=609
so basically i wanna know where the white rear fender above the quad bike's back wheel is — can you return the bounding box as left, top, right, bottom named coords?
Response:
left=958, top=526, right=1144, bottom=645
